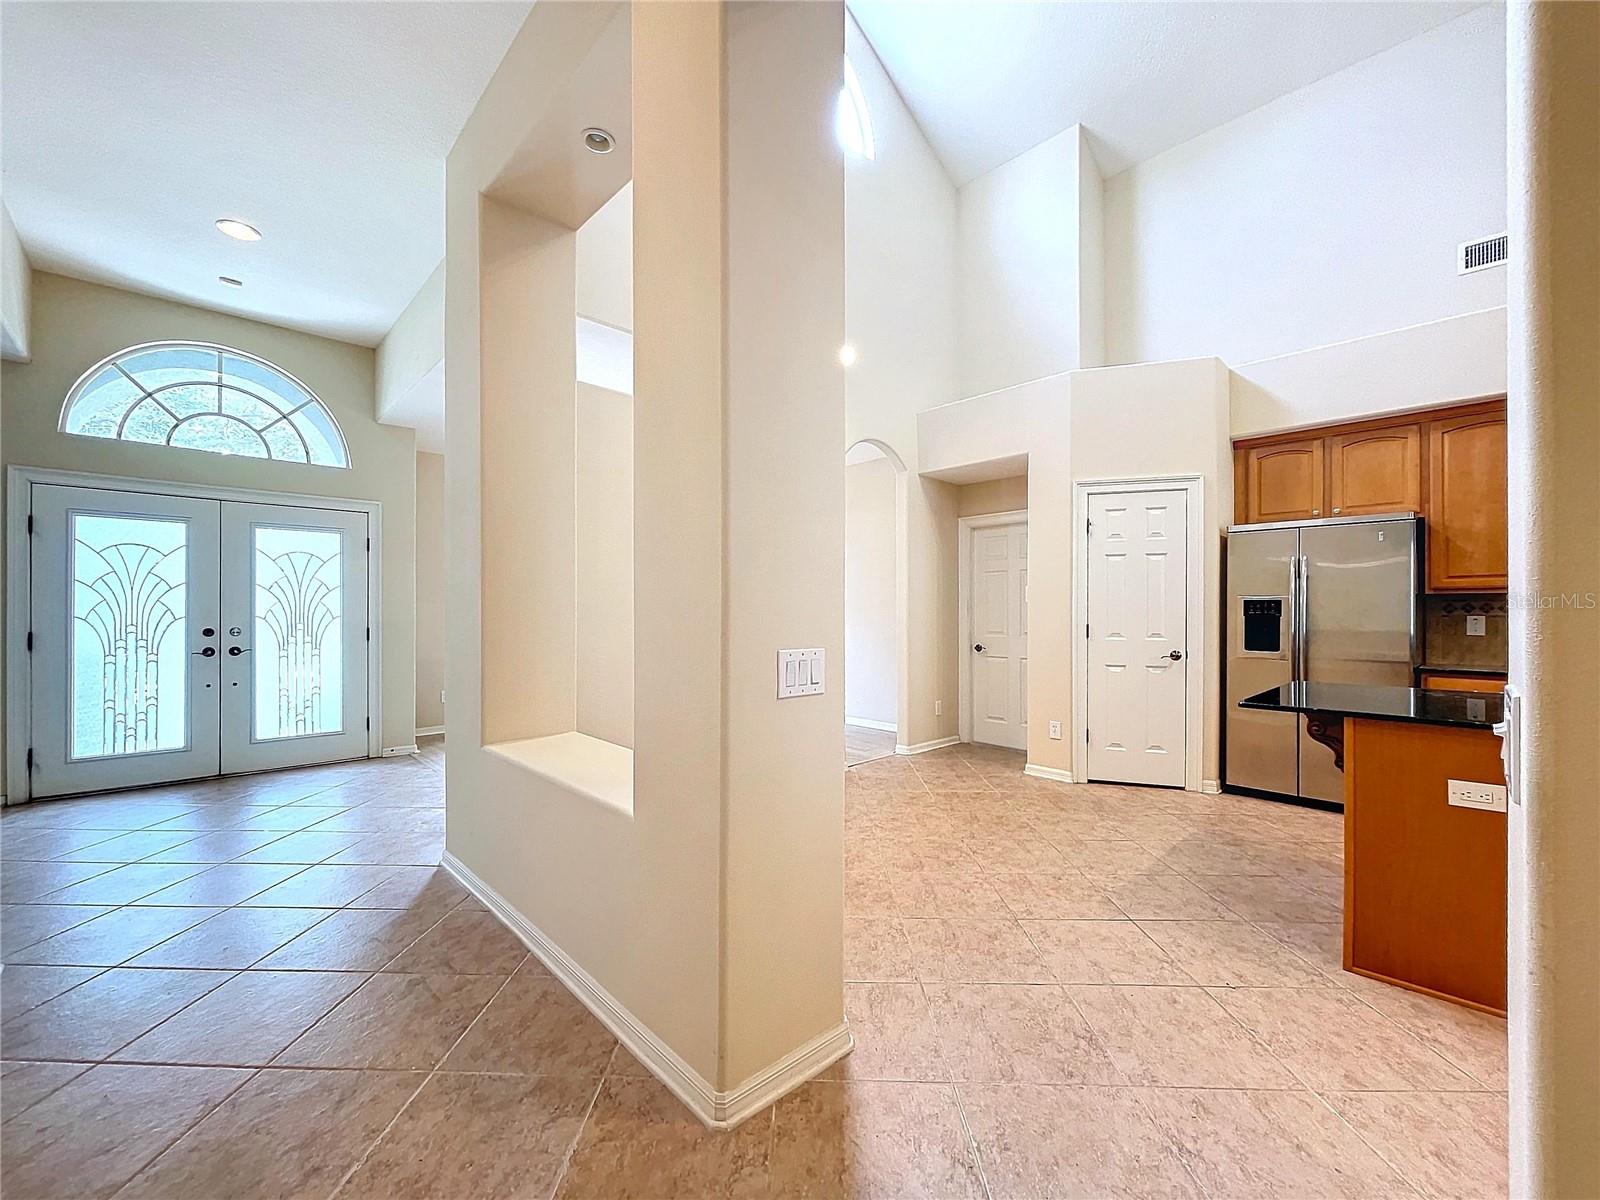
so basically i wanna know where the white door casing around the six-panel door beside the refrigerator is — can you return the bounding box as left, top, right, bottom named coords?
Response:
left=1072, top=474, right=1210, bottom=792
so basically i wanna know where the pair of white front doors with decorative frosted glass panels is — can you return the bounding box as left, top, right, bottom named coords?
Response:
left=27, top=483, right=370, bottom=797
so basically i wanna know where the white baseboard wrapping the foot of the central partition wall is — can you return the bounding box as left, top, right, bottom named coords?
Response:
left=442, top=851, right=854, bottom=1130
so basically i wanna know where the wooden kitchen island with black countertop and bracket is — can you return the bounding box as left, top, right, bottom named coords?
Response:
left=1240, top=683, right=1506, bottom=1016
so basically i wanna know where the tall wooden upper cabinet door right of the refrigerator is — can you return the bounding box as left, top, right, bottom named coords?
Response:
left=1427, top=411, right=1507, bottom=592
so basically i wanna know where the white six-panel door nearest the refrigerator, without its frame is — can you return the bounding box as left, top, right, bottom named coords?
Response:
left=1088, top=491, right=1189, bottom=787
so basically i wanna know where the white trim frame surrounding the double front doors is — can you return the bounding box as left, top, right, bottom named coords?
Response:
left=5, top=464, right=388, bottom=802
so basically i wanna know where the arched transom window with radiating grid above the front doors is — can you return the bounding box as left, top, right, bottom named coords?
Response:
left=61, top=342, right=350, bottom=467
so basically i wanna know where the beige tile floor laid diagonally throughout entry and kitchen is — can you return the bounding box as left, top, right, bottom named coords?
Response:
left=0, top=747, right=1506, bottom=1200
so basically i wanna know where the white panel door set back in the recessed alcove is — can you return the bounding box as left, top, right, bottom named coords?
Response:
left=966, top=520, right=1027, bottom=750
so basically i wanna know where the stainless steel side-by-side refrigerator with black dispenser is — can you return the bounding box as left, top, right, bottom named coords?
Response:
left=1222, top=514, right=1422, bottom=803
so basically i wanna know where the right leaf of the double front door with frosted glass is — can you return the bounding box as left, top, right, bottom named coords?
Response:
left=221, top=501, right=368, bottom=774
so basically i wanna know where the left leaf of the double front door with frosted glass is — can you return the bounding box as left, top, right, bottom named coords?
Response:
left=29, top=483, right=221, bottom=797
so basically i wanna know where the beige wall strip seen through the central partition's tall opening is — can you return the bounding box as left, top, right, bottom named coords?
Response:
left=573, top=380, right=634, bottom=747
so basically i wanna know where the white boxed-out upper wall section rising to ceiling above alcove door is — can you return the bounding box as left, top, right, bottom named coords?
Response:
left=958, top=125, right=1101, bottom=395
